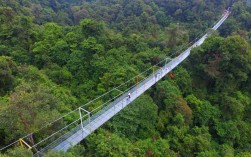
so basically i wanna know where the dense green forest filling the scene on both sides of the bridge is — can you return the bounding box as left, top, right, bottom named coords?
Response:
left=0, top=0, right=251, bottom=157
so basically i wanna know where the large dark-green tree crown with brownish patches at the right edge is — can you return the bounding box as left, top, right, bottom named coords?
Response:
left=190, top=36, right=251, bottom=94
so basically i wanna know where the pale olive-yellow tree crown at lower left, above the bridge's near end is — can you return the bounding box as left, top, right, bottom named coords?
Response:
left=1, top=83, right=59, bottom=142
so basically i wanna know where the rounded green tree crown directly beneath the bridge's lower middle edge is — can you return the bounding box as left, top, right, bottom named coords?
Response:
left=111, top=95, right=157, bottom=140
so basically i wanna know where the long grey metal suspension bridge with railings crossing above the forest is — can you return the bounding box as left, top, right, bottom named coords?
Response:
left=0, top=9, right=230, bottom=156
